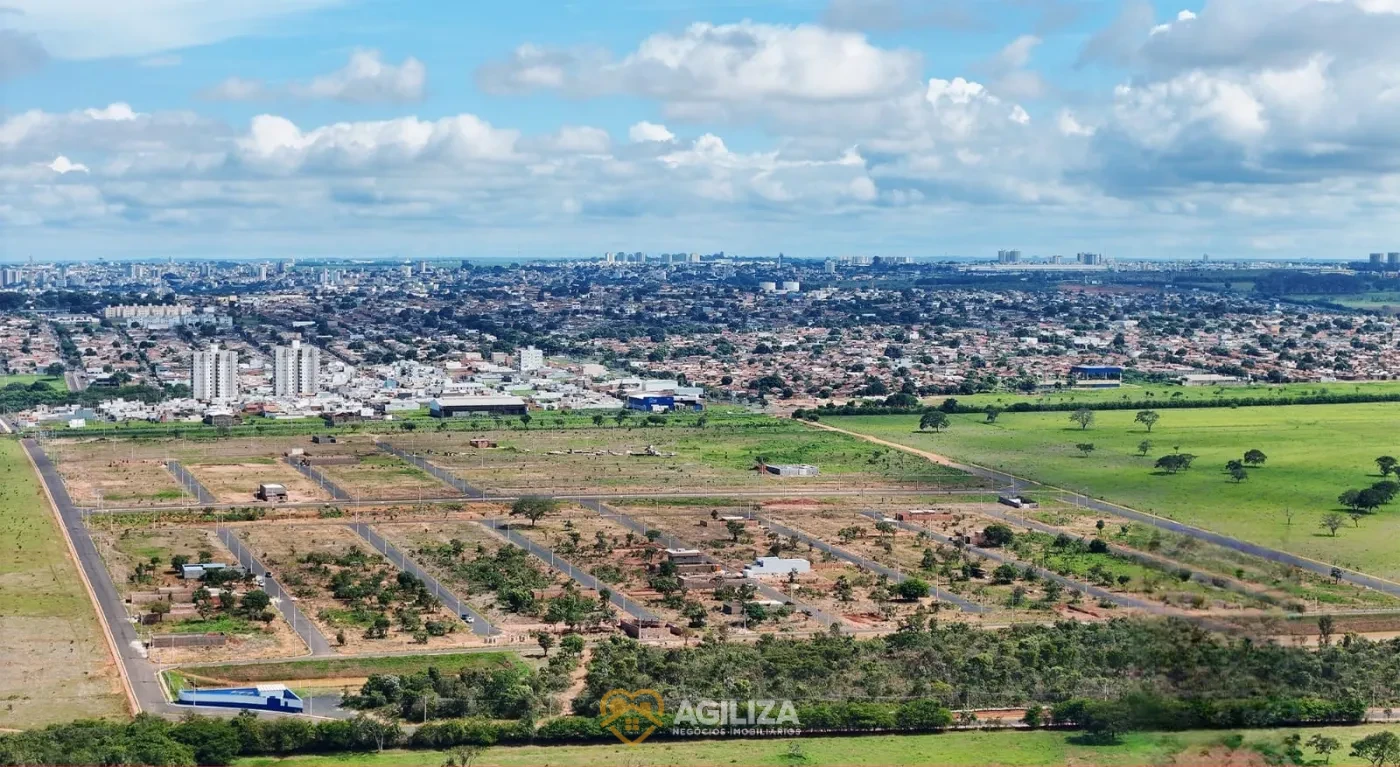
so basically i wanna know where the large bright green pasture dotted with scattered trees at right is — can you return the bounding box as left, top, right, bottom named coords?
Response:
left=822, top=403, right=1400, bottom=578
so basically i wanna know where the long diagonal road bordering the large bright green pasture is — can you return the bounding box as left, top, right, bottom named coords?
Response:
left=811, top=424, right=1400, bottom=596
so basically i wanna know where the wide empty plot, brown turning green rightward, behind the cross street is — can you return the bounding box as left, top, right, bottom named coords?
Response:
left=392, top=420, right=979, bottom=493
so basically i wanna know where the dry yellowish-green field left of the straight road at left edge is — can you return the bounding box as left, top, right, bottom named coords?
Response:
left=0, top=439, right=126, bottom=728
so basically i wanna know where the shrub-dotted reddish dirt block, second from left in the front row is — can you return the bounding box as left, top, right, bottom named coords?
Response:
left=238, top=523, right=482, bottom=652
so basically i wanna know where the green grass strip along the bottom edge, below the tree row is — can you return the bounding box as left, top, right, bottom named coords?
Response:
left=235, top=726, right=1400, bottom=767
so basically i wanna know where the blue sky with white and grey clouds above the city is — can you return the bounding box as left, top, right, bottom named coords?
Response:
left=0, top=0, right=1400, bottom=262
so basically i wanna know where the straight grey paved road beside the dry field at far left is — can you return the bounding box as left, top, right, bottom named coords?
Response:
left=21, top=439, right=178, bottom=714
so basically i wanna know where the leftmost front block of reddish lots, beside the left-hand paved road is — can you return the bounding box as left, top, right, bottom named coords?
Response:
left=92, top=523, right=307, bottom=663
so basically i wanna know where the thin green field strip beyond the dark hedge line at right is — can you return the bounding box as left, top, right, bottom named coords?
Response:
left=925, top=381, right=1400, bottom=407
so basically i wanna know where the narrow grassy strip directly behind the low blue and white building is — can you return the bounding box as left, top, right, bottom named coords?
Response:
left=181, top=651, right=521, bottom=682
